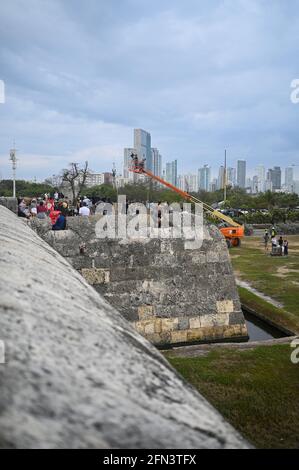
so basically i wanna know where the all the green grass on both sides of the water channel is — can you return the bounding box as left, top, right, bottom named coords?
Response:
left=166, top=236, right=299, bottom=448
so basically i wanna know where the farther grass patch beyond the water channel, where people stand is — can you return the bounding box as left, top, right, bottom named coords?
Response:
left=230, top=235, right=299, bottom=333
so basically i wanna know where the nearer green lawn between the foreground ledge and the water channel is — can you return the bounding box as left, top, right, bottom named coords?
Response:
left=166, top=345, right=299, bottom=448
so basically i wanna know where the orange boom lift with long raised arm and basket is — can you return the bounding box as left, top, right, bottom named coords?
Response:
left=130, top=153, right=244, bottom=248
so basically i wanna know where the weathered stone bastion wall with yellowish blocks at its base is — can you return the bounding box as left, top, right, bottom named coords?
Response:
left=32, top=215, right=247, bottom=346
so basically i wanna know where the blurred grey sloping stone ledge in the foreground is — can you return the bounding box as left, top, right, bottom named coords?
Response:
left=0, top=207, right=247, bottom=449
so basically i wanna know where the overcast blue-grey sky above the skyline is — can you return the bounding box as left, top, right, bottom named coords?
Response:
left=0, top=0, right=299, bottom=180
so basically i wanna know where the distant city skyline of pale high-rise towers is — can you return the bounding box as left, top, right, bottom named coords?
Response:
left=119, top=129, right=299, bottom=193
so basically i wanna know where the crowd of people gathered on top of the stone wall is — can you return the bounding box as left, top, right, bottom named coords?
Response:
left=18, top=191, right=107, bottom=230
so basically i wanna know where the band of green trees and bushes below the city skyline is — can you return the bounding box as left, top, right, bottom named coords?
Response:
left=0, top=178, right=299, bottom=224
